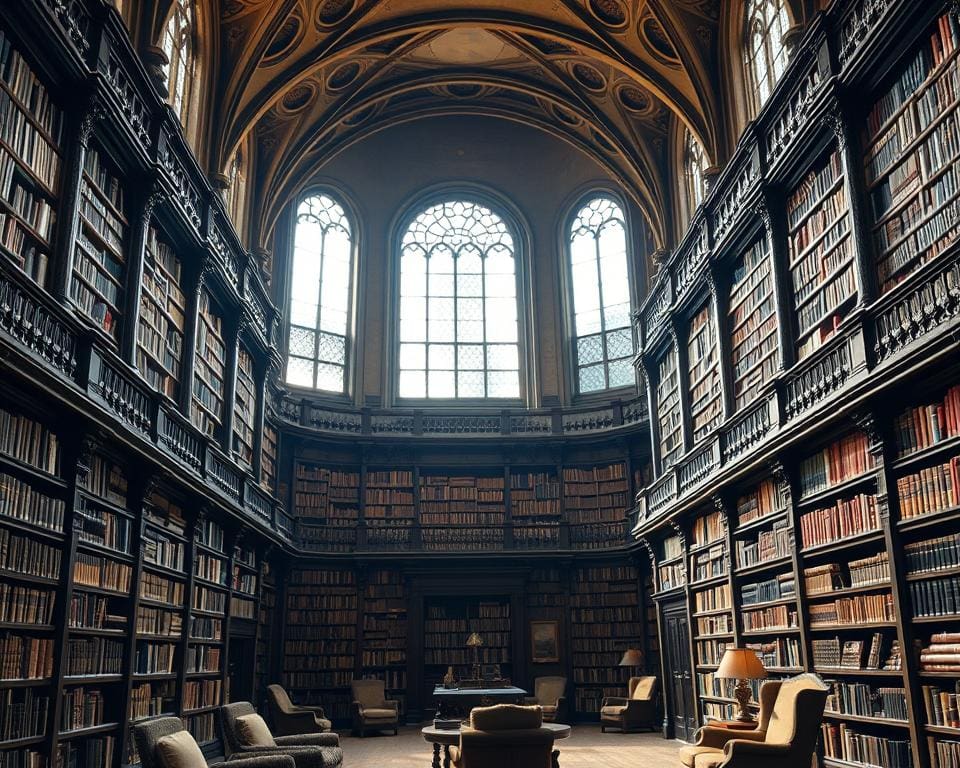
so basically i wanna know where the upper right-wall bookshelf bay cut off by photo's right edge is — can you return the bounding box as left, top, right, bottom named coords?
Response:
left=863, top=13, right=960, bottom=292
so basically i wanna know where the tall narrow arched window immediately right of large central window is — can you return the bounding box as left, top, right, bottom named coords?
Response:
left=569, top=196, right=636, bottom=394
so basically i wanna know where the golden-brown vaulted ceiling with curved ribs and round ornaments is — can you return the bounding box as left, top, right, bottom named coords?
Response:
left=213, top=0, right=724, bottom=243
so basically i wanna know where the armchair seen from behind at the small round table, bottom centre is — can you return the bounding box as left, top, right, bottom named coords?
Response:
left=450, top=704, right=554, bottom=768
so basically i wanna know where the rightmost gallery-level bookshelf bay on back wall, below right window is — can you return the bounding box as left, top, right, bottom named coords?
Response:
left=563, top=462, right=630, bottom=549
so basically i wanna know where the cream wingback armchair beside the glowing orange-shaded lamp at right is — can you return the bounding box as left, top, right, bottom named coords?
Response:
left=680, top=673, right=829, bottom=768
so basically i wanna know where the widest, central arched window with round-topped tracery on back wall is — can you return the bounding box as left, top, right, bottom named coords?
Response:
left=398, top=200, right=520, bottom=399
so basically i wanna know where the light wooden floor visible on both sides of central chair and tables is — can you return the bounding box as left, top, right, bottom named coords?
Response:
left=340, top=724, right=680, bottom=768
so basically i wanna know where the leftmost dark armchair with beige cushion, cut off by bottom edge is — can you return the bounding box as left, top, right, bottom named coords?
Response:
left=133, top=717, right=296, bottom=768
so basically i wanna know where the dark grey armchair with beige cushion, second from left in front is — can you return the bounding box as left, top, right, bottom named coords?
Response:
left=220, top=701, right=343, bottom=768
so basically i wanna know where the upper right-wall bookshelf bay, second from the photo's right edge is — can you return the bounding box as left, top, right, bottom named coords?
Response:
left=787, top=149, right=857, bottom=360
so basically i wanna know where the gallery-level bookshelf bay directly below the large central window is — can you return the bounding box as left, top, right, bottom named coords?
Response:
left=422, top=472, right=506, bottom=551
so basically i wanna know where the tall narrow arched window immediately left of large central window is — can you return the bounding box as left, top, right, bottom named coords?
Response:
left=286, top=194, right=353, bottom=393
